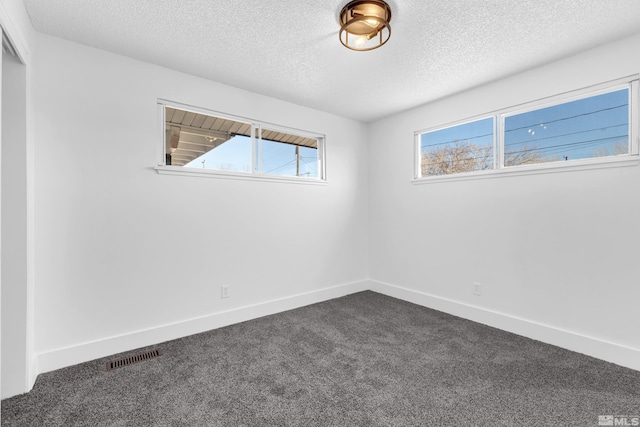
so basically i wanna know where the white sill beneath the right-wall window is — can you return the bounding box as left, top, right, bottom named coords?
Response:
left=411, top=155, right=640, bottom=185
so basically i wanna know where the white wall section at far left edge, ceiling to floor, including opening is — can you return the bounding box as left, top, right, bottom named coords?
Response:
left=0, top=0, right=37, bottom=398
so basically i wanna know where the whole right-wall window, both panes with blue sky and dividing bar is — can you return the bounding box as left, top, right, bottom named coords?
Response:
left=415, top=76, right=640, bottom=178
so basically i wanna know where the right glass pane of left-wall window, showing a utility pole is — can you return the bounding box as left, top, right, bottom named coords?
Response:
left=262, top=129, right=318, bottom=178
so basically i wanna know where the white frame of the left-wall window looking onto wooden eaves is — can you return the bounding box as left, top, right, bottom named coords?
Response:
left=154, top=99, right=327, bottom=185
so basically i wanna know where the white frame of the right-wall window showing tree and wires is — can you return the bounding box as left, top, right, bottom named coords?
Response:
left=412, top=75, right=640, bottom=184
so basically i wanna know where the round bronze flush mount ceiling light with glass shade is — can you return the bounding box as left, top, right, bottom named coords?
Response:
left=340, top=0, right=391, bottom=50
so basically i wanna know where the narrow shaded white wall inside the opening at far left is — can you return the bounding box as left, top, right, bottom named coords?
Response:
left=1, top=54, right=28, bottom=402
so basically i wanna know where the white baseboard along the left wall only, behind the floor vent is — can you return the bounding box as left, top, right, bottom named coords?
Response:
left=37, top=281, right=369, bottom=374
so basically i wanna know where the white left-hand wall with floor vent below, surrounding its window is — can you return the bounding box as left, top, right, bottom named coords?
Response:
left=34, top=35, right=368, bottom=372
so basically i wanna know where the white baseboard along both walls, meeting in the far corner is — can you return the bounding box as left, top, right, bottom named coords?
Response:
left=33, top=280, right=640, bottom=391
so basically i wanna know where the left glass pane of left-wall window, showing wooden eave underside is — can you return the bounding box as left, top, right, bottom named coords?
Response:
left=165, top=107, right=251, bottom=172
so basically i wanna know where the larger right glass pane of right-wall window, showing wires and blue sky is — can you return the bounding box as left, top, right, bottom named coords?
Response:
left=504, top=89, right=629, bottom=166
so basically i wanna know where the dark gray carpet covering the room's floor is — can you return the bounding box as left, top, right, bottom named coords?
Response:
left=2, top=292, right=640, bottom=426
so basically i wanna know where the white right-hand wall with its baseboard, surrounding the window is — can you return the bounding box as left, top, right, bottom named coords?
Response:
left=369, top=36, right=640, bottom=369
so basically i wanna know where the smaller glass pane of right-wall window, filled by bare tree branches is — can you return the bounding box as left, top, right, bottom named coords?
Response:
left=420, top=117, right=494, bottom=176
